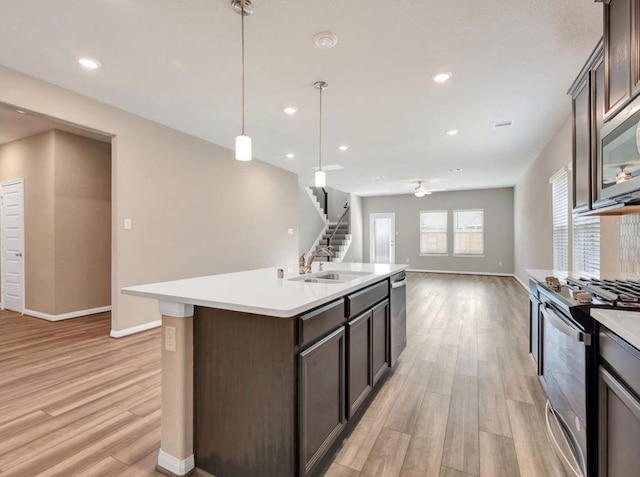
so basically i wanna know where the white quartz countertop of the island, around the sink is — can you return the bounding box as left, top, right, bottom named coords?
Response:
left=122, top=262, right=407, bottom=318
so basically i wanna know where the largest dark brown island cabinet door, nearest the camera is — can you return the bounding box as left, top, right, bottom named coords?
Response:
left=298, top=326, right=345, bottom=476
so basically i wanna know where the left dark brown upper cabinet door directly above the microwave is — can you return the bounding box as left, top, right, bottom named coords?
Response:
left=604, top=0, right=635, bottom=119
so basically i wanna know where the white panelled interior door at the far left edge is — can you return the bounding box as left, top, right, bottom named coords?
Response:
left=1, top=179, right=24, bottom=313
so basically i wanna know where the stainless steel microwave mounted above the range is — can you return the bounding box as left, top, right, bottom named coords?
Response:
left=596, top=94, right=640, bottom=203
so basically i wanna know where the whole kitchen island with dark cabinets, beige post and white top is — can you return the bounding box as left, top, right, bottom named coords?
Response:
left=122, top=263, right=406, bottom=477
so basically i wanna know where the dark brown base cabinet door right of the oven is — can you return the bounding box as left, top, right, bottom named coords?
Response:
left=598, top=367, right=640, bottom=477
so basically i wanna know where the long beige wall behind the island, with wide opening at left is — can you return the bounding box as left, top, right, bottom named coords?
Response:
left=0, top=66, right=299, bottom=331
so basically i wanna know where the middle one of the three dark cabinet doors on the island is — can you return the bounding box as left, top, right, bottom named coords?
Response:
left=347, top=311, right=373, bottom=419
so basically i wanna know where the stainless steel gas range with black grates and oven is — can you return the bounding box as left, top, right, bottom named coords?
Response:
left=538, top=277, right=640, bottom=477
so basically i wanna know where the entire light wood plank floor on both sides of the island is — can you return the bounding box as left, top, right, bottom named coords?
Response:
left=0, top=274, right=565, bottom=477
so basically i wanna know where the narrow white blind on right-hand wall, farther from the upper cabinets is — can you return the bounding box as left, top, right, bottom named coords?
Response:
left=550, top=170, right=569, bottom=270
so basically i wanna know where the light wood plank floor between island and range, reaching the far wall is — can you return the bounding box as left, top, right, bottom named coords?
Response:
left=325, top=273, right=565, bottom=477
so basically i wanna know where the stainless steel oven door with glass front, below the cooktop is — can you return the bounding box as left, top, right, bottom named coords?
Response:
left=542, top=303, right=591, bottom=477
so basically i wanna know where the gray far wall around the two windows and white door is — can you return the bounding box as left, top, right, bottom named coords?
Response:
left=363, top=188, right=513, bottom=274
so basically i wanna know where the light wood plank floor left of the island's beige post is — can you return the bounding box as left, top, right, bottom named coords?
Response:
left=0, top=311, right=161, bottom=477
